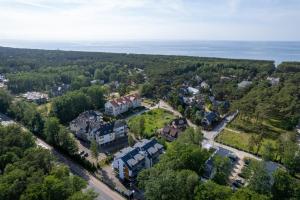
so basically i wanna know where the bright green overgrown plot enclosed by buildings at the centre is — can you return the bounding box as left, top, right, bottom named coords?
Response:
left=128, top=108, right=175, bottom=138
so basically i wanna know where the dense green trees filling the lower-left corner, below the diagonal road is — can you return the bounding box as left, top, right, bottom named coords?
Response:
left=0, top=126, right=97, bottom=200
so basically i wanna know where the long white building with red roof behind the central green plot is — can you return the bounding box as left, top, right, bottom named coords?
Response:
left=105, top=94, right=141, bottom=116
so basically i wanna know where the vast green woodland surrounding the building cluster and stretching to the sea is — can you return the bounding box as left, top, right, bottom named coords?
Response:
left=0, top=47, right=300, bottom=200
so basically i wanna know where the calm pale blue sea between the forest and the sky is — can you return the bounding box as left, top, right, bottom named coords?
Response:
left=0, top=41, right=300, bottom=64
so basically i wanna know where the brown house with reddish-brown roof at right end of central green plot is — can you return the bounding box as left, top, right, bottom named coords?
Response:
left=161, top=118, right=188, bottom=142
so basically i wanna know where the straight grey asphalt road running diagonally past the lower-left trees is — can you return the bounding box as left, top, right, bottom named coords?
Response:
left=0, top=113, right=125, bottom=200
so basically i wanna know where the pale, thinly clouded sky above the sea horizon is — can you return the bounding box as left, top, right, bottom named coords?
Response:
left=0, top=0, right=300, bottom=41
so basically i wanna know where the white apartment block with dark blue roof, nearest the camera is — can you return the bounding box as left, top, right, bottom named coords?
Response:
left=112, top=139, right=163, bottom=181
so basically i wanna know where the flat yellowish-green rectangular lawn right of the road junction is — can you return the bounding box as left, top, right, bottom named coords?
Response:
left=216, top=129, right=275, bottom=155
